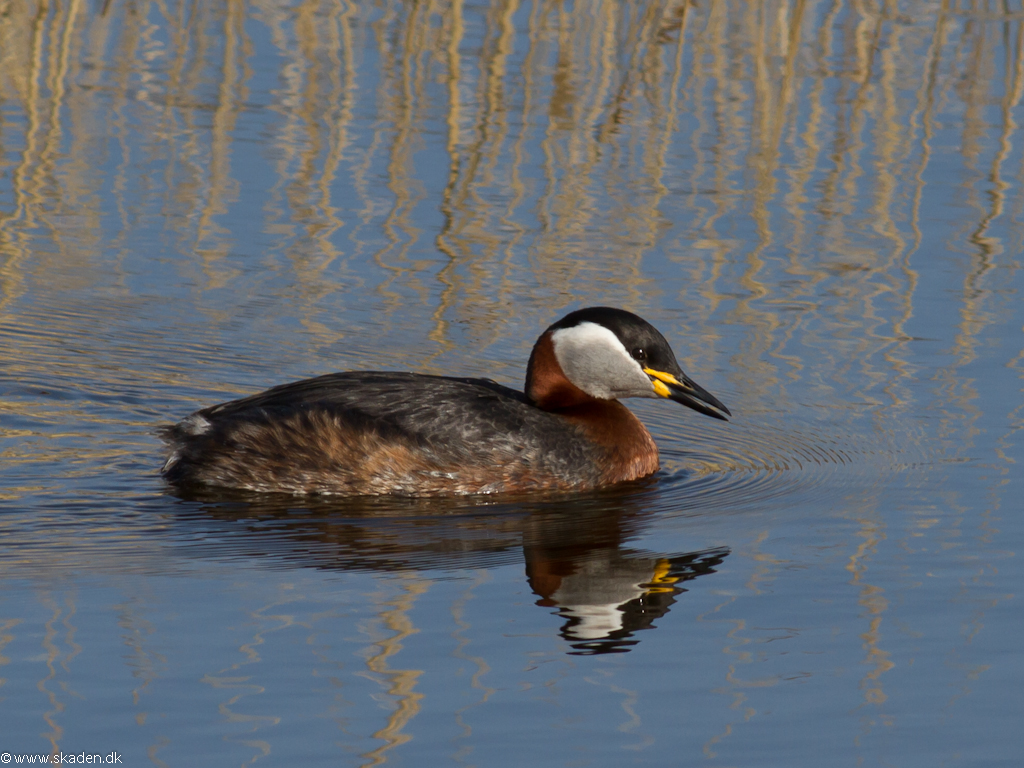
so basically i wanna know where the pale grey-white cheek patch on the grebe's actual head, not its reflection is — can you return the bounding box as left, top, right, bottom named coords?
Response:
left=551, top=323, right=657, bottom=400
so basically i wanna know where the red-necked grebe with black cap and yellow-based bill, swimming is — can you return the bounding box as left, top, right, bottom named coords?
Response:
left=162, top=307, right=731, bottom=496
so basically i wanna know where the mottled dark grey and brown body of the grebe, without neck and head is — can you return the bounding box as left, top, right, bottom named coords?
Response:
left=158, top=373, right=614, bottom=496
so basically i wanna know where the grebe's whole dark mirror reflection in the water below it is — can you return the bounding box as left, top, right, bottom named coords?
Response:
left=165, top=490, right=729, bottom=654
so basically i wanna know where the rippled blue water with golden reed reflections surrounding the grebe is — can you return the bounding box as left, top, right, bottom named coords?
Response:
left=0, top=0, right=1024, bottom=766
